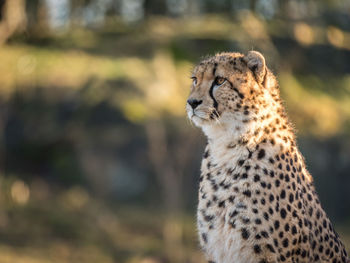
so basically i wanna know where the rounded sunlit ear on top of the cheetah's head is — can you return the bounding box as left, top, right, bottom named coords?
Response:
left=244, top=51, right=266, bottom=84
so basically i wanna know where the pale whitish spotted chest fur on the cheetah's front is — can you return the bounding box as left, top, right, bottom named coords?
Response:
left=197, top=145, right=273, bottom=263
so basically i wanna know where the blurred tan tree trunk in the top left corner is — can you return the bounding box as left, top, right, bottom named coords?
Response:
left=0, top=0, right=27, bottom=44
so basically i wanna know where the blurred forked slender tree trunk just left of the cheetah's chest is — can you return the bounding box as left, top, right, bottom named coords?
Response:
left=146, top=119, right=197, bottom=262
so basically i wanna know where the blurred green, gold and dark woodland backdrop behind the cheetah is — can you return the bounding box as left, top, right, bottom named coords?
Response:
left=0, top=0, right=350, bottom=263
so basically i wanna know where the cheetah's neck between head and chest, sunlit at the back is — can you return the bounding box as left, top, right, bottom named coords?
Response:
left=203, top=95, right=296, bottom=166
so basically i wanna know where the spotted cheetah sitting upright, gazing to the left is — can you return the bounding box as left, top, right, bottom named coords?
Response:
left=186, top=51, right=350, bottom=263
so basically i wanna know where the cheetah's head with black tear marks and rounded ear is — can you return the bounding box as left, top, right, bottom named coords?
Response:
left=186, top=51, right=279, bottom=139
